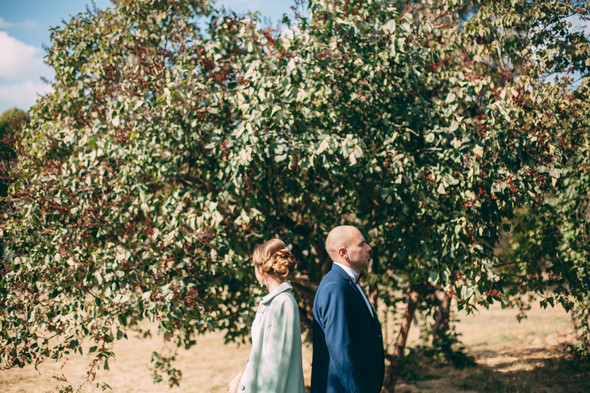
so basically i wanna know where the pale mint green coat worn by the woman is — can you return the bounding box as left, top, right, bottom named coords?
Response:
left=238, top=282, right=305, bottom=393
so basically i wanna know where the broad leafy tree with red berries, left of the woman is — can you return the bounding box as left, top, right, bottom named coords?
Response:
left=0, top=0, right=259, bottom=384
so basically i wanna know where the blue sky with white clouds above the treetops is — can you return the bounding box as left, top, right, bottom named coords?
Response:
left=0, top=0, right=294, bottom=113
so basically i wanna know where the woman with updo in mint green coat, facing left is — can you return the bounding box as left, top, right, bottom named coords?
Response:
left=228, top=239, right=305, bottom=393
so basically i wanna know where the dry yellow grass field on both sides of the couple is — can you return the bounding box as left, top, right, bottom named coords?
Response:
left=0, top=298, right=590, bottom=393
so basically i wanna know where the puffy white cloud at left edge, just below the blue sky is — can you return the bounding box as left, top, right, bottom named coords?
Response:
left=0, top=31, right=51, bottom=81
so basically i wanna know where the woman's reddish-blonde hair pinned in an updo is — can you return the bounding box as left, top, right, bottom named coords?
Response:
left=252, top=239, right=297, bottom=278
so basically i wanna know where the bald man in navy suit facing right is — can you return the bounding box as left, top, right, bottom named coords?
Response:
left=311, top=225, right=385, bottom=393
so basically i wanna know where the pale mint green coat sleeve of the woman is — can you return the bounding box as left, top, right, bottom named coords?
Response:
left=258, top=297, right=296, bottom=393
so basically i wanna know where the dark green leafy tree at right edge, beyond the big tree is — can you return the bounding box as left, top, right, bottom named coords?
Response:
left=500, top=82, right=590, bottom=359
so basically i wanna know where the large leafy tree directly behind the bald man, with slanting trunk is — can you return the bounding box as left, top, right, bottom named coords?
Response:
left=231, top=1, right=588, bottom=388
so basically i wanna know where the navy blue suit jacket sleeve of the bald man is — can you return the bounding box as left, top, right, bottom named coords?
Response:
left=319, top=282, right=366, bottom=393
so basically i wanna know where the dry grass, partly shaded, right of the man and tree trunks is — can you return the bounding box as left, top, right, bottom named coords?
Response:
left=396, top=300, right=590, bottom=393
